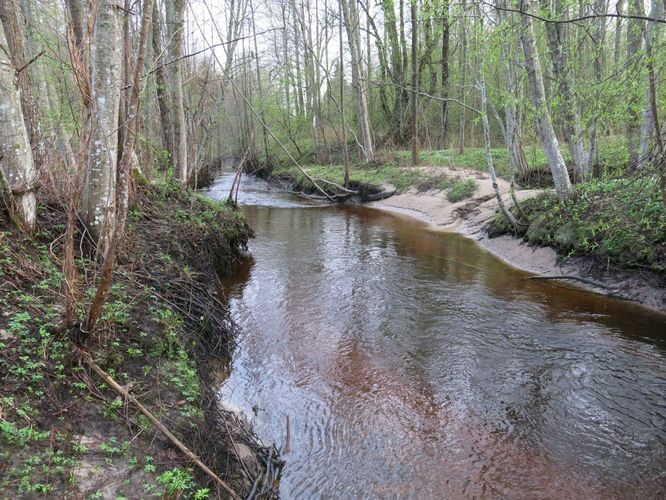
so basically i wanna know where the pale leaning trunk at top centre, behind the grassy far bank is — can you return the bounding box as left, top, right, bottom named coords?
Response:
left=340, top=0, right=374, bottom=161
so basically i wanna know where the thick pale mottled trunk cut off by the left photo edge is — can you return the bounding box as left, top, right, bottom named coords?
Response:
left=0, top=19, right=37, bottom=232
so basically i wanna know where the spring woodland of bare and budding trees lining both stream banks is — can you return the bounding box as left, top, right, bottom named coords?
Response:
left=0, top=0, right=666, bottom=498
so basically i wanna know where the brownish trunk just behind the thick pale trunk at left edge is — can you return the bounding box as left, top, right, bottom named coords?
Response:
left=0, top=0, right=46, bottom=171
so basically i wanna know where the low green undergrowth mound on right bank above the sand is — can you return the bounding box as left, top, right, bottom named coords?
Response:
left=490, top=176, right=666, bottom=275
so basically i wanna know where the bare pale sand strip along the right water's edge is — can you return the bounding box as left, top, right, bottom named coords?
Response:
left=368, top=167, right=666, bottom=312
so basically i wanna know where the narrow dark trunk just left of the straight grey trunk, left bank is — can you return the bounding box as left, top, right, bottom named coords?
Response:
left=152, top=3, right=176, bottom=170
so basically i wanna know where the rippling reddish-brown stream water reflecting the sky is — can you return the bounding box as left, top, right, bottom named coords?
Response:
left=211, top=172, right=666, bottom=498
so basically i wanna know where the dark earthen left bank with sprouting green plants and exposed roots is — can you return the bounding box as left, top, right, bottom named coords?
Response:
left=0, top=184, right=279, bottom=499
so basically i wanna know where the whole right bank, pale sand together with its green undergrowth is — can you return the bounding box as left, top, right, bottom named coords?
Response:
left=256, top=157, right=666, bottom=311
